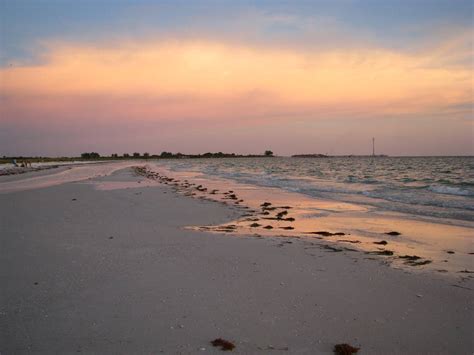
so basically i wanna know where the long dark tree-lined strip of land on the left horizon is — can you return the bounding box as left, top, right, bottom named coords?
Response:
left=0, top=150, right=273, bottom=164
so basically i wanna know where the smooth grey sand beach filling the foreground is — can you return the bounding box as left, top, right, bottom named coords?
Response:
left=0, top=165, right=474, bottom=354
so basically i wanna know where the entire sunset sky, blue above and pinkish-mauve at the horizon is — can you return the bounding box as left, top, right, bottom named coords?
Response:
left=0, top=0, right=474, bottom=156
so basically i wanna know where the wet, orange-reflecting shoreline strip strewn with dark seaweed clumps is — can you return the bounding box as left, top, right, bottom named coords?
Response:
left=137, top=164, right=474, bottom=280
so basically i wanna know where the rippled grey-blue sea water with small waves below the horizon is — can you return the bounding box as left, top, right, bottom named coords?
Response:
left=159, top=157, right=474, bottom=222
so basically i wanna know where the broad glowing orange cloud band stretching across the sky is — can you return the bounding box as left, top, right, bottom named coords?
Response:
left=0, top=41, right=473, bottom=124
